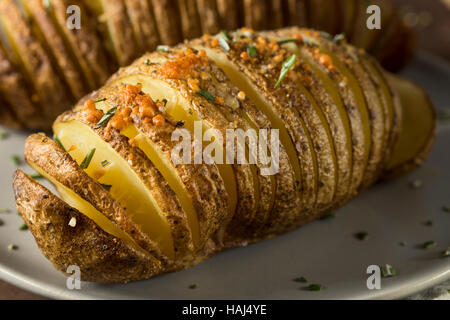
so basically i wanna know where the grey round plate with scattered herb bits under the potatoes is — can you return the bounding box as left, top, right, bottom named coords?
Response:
left=0, top=55, right=450, bottom=299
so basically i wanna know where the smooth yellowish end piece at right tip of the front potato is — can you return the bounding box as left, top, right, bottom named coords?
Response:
left=385, top=74, right=436, bottom=178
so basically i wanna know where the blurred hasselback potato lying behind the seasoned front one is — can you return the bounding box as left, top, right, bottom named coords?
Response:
left=0, top=0, right=414, bottom=130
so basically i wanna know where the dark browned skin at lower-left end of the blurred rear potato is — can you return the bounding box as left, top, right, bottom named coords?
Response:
left=0, top=46, right=50, bottom=130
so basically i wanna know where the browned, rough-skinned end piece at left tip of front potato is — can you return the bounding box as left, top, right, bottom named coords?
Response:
left=13, top=170, right=161, bottom=282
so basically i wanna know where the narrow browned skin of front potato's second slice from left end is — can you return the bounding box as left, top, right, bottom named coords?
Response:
left=25, top=134, right=167, bottom=265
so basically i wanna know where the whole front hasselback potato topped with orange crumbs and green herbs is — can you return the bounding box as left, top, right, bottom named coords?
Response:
left=13, top=28, right=435, bottom=282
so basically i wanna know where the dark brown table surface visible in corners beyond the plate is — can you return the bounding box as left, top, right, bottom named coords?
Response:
left=0, top=0, right=450, bottom=300
